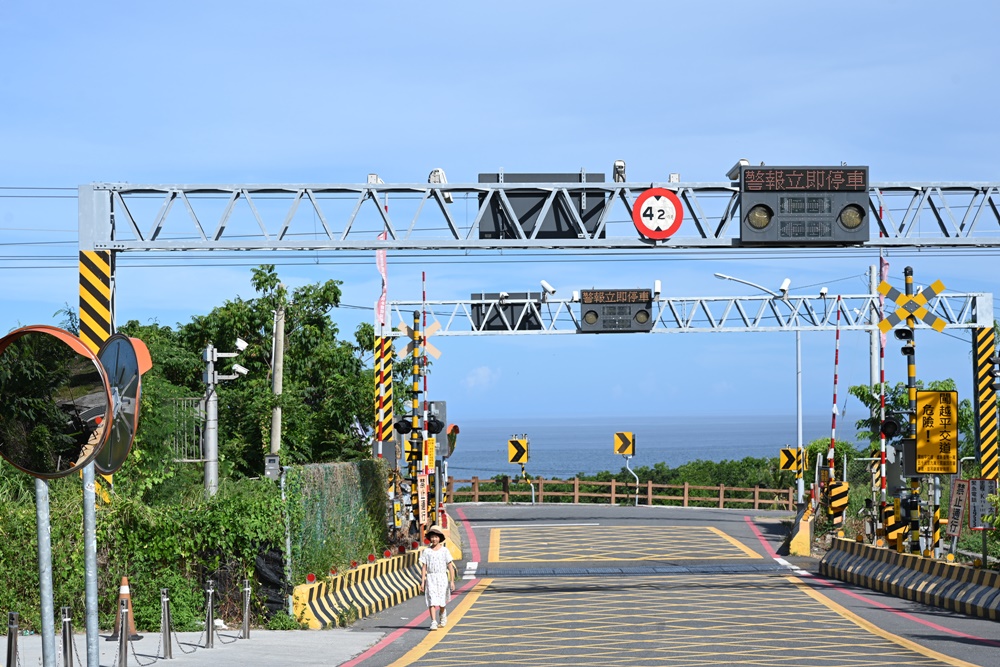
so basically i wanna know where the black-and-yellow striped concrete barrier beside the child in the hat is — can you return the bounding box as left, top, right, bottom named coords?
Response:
left=292, top=550, right=420, bottom=630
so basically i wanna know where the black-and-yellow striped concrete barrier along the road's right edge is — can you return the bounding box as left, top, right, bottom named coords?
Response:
left=819, top=539, right=1000, bottom=621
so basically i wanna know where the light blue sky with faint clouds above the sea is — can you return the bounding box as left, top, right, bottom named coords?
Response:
left=0, top=0, right=1000, bottom=431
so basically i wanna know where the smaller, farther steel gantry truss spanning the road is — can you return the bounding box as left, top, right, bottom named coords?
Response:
left=387, top=293, right=993, bottom=336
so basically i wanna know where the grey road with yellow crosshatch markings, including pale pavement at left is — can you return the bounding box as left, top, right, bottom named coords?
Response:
left=9, top=504, right=1000, bottom=667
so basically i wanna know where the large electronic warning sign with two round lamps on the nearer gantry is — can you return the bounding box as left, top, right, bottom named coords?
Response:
left=739, top=164, right=870, bottom=247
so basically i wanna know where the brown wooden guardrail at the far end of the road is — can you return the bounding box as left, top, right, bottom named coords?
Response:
left=448, top=477, right=795, bottom=510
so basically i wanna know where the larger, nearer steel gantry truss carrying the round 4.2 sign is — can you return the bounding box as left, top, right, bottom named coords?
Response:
left=79, top=179, right=1000, bottom=252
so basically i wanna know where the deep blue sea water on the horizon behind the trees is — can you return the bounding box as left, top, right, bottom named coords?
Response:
left=439, top=415, right=857, bottom=479
